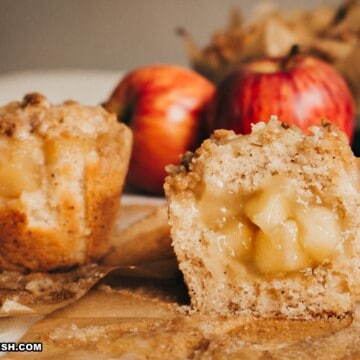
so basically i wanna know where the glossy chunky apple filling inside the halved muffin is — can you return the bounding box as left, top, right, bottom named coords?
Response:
left=199, top=175, right=342, bottom=274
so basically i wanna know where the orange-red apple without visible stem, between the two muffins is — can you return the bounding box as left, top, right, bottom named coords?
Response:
left=104, top=65, right=215, bottom=194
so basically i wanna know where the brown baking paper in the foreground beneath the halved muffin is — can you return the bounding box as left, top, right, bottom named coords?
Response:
left=5, top=279, right=360, bottom=360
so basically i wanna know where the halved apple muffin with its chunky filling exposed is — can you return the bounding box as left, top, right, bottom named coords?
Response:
left=164, top=117, right=360, bottom=319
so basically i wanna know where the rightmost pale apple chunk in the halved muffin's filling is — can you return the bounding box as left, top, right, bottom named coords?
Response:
left=296, top=206, right=341, bottom=262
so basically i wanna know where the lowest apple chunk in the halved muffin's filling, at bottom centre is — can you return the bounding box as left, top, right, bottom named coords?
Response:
left=254, top=220, right=311, bottom=273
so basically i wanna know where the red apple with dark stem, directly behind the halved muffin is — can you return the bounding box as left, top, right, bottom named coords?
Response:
left=208, top=54, right=355, bottom=142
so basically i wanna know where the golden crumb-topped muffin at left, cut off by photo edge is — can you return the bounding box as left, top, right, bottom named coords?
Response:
left=0, top=93, right=132, bottom=271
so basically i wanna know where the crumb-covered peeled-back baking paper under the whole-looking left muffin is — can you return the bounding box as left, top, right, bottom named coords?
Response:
left=0, top=260, right=178, bottom=317
